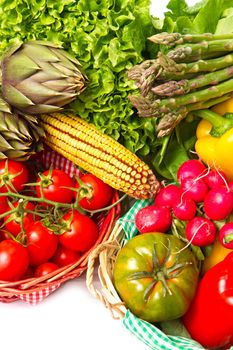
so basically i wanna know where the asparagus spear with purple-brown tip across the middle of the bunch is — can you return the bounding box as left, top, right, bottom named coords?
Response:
left=151, top=66, right=233, bottom=97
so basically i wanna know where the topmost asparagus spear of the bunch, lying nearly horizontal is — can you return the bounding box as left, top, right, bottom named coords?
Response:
left=148, top=32, right=233, bottom=46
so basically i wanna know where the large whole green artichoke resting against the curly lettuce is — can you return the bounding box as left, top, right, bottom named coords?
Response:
left=1, top=40, right=87, bottom=114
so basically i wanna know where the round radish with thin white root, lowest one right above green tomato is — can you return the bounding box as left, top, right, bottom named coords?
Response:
left=185, top=216, right=217, bottom=247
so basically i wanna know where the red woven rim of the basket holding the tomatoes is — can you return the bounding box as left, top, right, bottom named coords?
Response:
left=0, top=191, right=121, bottom=302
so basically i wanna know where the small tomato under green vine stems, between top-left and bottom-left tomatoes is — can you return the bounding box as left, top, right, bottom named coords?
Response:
left=3, top=201, right=37, bottom=237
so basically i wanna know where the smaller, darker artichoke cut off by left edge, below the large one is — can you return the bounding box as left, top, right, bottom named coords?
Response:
left=0, top=98, right=44, bottom=161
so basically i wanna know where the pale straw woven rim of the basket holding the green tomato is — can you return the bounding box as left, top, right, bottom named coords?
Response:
left=86, top=222, right=127, bottom=319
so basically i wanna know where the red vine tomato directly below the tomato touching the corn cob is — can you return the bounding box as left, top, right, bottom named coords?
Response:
left=59, top=210, right=99, bottom=252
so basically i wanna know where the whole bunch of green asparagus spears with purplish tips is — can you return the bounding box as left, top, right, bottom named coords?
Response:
left=128, top=33, right=233, bottom=137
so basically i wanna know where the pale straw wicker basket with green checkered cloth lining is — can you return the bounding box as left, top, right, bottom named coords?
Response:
left=86, top=215, right=211, bottom=350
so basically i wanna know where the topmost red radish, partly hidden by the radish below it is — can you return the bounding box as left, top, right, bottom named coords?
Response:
left=177, top=159, right=207, bottom=183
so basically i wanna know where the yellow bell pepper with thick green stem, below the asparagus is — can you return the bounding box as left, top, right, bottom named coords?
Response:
left=195, top=109, right=233, bottom=180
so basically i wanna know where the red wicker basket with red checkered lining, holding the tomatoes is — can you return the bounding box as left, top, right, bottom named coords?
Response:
left=0, top=149, right=121, bottom=304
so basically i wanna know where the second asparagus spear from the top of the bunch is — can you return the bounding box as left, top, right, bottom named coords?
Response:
left=167, top=39, right=233, bottom=62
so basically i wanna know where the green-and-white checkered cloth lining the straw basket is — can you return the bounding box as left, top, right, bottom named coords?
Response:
left=118, top=200, right=233, bottom=350
